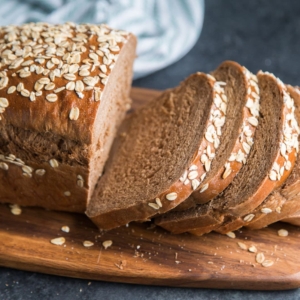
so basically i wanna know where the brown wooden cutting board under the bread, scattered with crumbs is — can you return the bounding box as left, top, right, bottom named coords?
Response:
left=0, top=89, right=300, bottom=290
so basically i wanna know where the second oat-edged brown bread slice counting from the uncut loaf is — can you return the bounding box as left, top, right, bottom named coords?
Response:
left=175, top=61, right=259, bottom=210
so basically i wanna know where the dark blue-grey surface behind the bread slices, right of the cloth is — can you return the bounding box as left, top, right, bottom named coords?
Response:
left=134, top=0, right=300, bottom=89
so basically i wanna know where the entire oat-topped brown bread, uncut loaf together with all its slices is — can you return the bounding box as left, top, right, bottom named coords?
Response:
left=0, top=23, right=300, bottom=235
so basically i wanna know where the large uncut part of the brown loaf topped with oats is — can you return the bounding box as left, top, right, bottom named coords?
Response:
left=0, top=23, right=136, bottom=212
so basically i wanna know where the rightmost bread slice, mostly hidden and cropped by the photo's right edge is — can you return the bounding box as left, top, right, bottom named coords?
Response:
left=244, top=86, right=300, bottom=229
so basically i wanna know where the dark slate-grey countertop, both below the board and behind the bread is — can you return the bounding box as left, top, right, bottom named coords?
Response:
left=0, top=0, right=300, bottom=300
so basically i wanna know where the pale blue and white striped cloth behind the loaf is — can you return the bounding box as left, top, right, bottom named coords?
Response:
left=0, top=0, right=204, bottom=78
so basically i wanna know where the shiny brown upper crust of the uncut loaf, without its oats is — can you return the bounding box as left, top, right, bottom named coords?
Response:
left=0, top=23, right=136, bottom=144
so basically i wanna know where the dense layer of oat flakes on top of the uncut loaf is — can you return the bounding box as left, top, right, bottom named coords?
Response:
left=0, top=22, right=128, bottom=121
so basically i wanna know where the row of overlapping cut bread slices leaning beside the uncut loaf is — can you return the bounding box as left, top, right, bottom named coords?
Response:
left=87, top=61, right=300, bottom=235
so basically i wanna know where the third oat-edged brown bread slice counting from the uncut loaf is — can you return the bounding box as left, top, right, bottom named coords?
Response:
left=158, top=72, right=297, bottom=235
